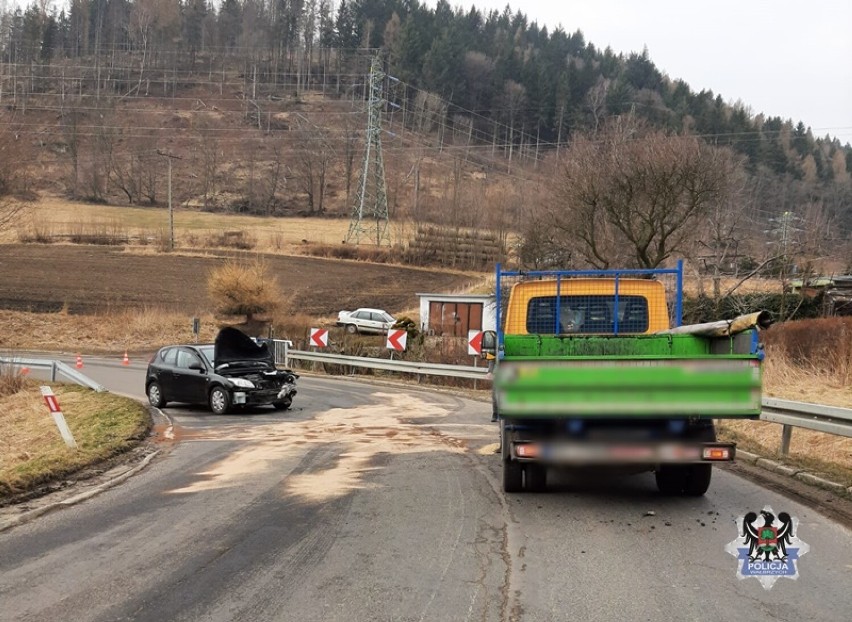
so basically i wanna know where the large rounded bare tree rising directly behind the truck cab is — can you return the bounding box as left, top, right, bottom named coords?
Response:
left=539, top=117, right=738, bottom=268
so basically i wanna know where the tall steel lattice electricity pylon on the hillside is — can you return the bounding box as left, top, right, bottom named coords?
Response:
left=346, top=55, right=390, bottom=246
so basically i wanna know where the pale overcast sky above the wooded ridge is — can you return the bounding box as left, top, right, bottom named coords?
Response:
left=446, top=0, right=852, bottom=142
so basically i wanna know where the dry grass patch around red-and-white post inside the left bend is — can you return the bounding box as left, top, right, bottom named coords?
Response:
left=0, top=380, right=150, bottom=504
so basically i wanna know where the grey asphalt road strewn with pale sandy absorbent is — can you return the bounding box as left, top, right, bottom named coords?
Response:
left=0, top=362, right=852, bottom=622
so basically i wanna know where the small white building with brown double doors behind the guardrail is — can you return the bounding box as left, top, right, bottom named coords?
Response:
left=417, top=294, right=497, bottom=338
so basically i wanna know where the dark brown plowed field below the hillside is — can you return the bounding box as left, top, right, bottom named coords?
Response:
left=0, top=244, right=476, bottom=316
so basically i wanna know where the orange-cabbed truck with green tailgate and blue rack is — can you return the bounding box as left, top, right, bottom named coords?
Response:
left=483, top=263, right=769, bottom=496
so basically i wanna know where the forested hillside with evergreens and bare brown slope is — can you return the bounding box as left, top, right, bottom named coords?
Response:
left=0, top=0, right=852, bottom=264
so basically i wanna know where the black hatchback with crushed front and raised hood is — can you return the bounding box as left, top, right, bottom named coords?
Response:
left=145, top=327, right=299, bottom=415
